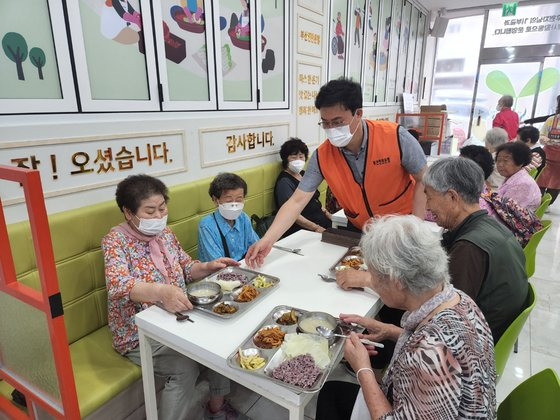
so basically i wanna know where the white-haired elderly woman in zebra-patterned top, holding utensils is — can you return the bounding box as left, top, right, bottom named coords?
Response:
left=316, top=216, right=496, bottom=420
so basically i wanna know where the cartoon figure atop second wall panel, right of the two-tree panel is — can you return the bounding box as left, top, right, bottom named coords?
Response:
left=101, top=0, right=142, bottom=44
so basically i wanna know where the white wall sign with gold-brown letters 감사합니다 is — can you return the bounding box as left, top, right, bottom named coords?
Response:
left=198, top=122, right=290, bottom=168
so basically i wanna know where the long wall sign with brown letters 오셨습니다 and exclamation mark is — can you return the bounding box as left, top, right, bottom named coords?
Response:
left=0, top=131, right=187, bottom=205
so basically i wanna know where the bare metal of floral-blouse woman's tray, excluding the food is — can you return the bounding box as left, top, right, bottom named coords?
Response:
left=193, top=267, right=280, bottom=319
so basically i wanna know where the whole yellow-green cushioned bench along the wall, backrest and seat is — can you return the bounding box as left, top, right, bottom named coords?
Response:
left=0, top=163, right=326, bottom=418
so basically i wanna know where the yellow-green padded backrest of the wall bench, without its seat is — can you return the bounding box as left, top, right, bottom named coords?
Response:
left=8, top=163, right=316, bottom=343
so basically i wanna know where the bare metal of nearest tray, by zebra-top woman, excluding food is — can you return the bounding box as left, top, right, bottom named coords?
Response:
left=227, top=305, right=352, bottom=393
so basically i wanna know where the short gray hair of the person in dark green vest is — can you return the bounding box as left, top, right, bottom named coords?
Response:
left=423, top=157, right=484, bottom=204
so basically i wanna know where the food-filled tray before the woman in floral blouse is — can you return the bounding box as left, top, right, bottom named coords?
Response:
left=187, top=267, right=280, bottom=319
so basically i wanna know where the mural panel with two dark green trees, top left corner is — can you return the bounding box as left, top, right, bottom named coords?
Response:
left=0, top=0, right=62, bottom=99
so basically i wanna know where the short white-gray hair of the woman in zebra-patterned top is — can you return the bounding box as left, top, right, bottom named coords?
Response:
left=360, top=215, right=449, bottom=295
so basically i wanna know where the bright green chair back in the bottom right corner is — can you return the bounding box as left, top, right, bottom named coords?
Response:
left=498, top=369, right=560, bottom=420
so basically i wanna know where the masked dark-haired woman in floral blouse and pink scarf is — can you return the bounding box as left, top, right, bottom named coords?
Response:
left=101, top=175, right=246, bottom=420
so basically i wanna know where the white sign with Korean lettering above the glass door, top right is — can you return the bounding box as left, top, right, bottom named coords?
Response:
left=484, top=3, right=560, bottom=48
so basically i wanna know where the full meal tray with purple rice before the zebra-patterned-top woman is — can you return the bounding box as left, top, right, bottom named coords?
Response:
left=227, top=305, right=352, bottom=393
